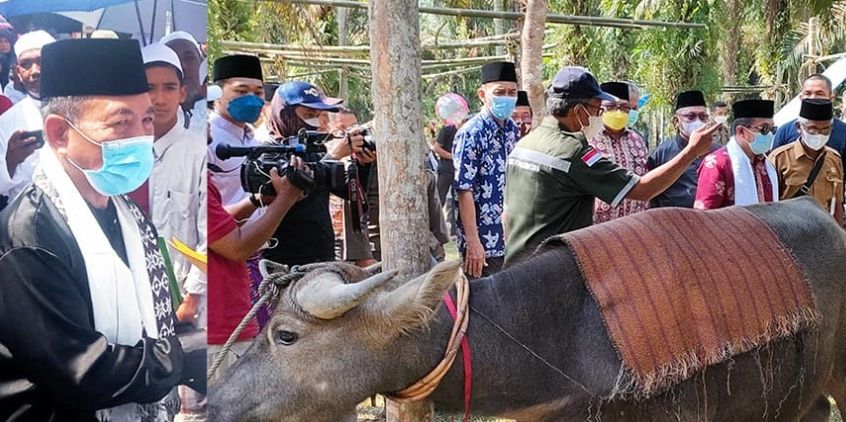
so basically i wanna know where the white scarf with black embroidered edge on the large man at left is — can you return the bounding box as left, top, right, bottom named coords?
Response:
left=34, top=147, right=173, bottom=346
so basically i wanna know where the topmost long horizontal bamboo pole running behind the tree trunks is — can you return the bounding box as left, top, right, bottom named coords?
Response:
left=261, top=0, right=708, bottom=29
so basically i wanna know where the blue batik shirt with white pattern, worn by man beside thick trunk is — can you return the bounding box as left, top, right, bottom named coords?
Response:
left=452, top=110, right=520, bottom=258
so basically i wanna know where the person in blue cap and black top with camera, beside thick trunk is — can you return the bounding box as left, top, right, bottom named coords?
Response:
left=263, top=81, right=376, bottom=265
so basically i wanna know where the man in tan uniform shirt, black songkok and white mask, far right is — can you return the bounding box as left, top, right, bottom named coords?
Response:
left=769, top=99, right=843, bottom=225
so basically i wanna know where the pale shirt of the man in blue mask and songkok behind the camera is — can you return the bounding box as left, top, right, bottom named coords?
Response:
left=208, top=112, right=259, bottom=206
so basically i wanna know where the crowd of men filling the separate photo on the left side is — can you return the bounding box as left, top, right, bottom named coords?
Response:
left=0, top=30, right=208, bottom=421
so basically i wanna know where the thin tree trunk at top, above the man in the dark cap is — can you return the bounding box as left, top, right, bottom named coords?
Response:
left=520, top=0, right=547, bottom=127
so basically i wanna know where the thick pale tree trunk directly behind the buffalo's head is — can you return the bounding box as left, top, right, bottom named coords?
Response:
left=369, top=0, right=434, bottom=422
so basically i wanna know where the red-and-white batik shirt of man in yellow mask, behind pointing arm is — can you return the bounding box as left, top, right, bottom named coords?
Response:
left=588, top=129, right=649, bottom=224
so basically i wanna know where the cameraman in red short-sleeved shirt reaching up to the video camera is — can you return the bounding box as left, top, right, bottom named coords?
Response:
left=208, top=157, right=309, bottom=380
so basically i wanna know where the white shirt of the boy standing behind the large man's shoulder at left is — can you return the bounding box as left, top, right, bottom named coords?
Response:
left=149, top=112, right=207, bottom=328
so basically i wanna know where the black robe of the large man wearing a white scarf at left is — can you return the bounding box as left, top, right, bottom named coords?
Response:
left=0, top=186, right=183, bottom=421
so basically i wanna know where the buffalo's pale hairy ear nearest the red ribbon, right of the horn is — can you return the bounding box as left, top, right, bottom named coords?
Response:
left=365, top=260, right=463, bottom=336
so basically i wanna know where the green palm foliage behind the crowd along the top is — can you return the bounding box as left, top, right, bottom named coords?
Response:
left=209, top=0, right=846, bottom=138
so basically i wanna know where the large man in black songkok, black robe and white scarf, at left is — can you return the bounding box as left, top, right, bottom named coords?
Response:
left=0, top=39, right=205, bottom=421
